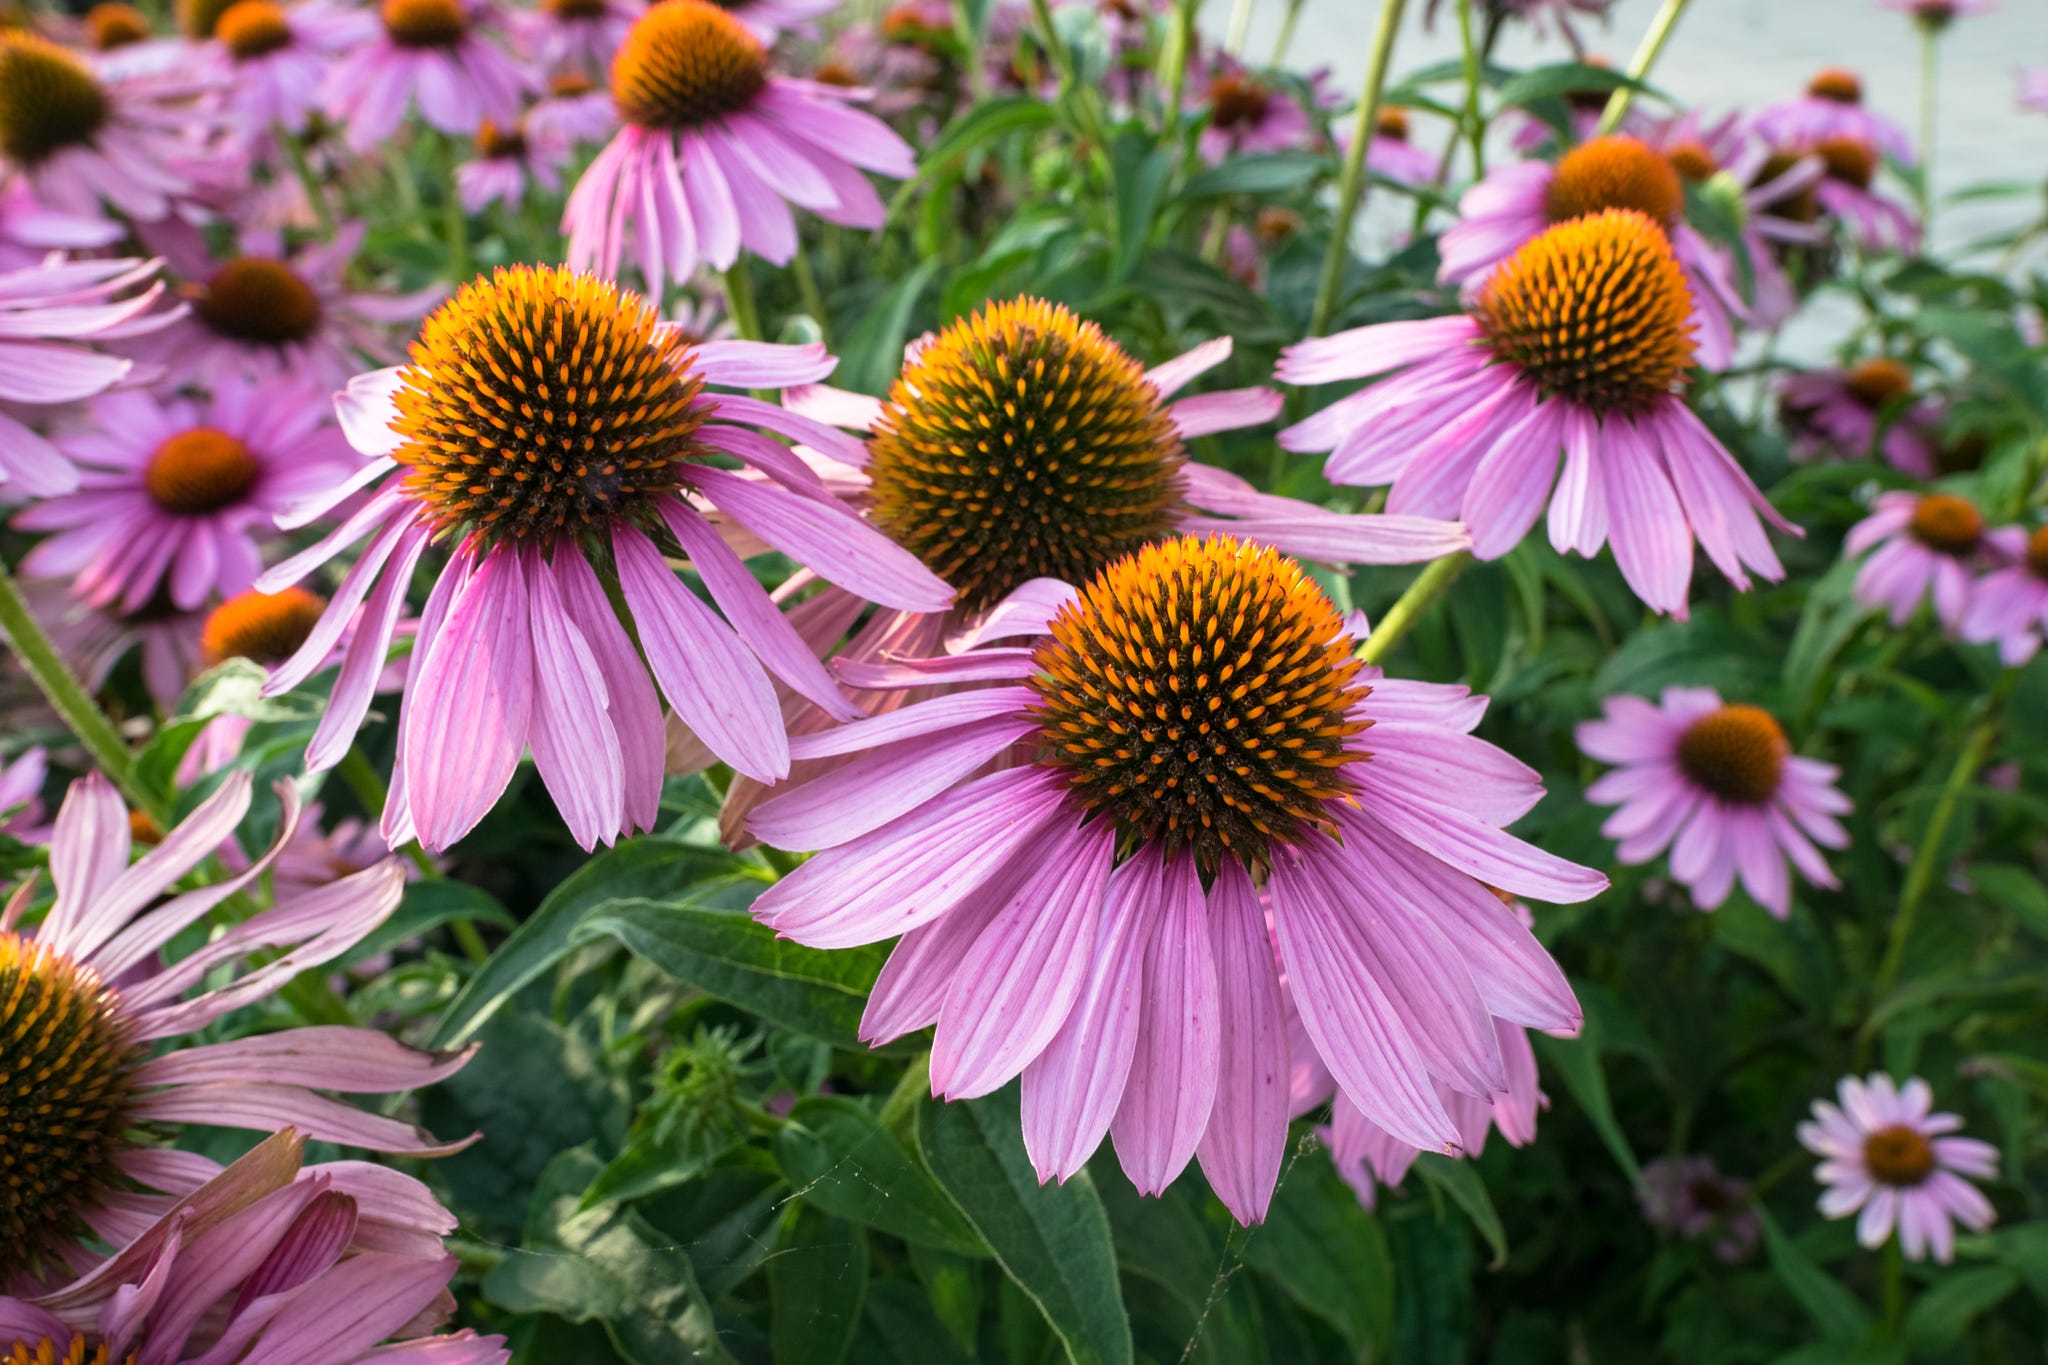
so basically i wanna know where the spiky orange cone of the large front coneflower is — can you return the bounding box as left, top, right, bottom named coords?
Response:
left=1032, top=536, right=1370, bottom=870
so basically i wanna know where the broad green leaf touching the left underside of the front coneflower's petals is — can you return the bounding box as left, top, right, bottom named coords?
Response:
left=569, top=898, right=889, bottom=1048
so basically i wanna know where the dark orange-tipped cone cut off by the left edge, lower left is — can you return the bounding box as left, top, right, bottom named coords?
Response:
left=0, top=933, right=137, bottom=1283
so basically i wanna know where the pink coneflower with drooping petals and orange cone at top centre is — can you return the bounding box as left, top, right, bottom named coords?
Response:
left=561, top=0, right=915, bottom=295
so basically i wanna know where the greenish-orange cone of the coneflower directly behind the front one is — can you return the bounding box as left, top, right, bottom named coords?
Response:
left=868, top=299, right=1186, bottom=610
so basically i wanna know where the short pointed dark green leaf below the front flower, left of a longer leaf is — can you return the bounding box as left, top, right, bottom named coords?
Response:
left=774, top=1095, right=989, bottom=1257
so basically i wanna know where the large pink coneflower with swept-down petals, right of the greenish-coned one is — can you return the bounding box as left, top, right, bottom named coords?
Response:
left=1278, top=209, right=1798, bottom=616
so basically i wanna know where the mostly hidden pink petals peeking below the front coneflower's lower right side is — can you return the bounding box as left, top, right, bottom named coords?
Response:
left=1288, top=1001, right=1550, bottom=1209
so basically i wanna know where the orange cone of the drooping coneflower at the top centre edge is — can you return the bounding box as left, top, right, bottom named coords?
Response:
left=612, top=0, right=768, bottom=129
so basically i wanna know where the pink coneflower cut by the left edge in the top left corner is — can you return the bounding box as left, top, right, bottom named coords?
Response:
left=0, top=31, right=221, bottom=223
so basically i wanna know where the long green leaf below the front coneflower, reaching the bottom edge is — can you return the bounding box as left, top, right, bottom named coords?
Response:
left=918, top=1085, right=1133, bottom=1365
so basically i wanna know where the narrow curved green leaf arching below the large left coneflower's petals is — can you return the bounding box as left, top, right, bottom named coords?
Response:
left=434, top=837, right=733, bottom=1048
